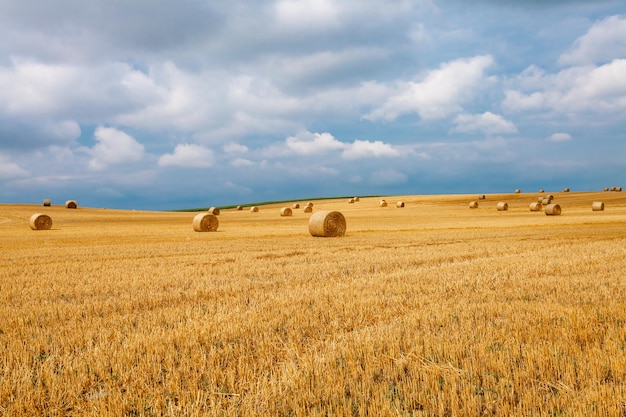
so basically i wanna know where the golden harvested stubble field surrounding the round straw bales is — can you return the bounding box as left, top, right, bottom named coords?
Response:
left=0, top=192, right=626, bottom=416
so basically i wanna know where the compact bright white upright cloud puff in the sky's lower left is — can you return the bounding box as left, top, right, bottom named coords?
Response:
left=88, top=126, right=144, bottom=171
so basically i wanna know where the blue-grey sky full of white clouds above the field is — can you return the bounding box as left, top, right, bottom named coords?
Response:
left=0, top=0, right=626, bottom=210
